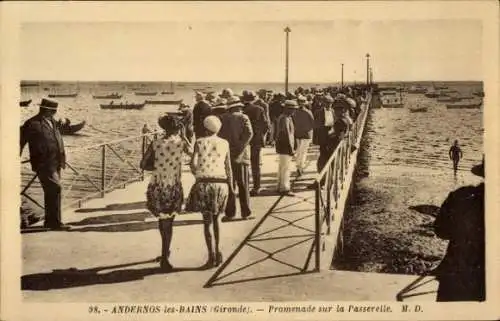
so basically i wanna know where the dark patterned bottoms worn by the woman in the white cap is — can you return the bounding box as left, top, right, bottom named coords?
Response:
left=186, top=182, right=229, bottom=215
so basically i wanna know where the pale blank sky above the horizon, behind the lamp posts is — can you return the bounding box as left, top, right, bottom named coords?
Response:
left=20, top=20, right=482, bottom=82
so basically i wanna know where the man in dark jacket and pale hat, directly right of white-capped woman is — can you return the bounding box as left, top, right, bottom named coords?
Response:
left=218, top=96, right=253, bottom=221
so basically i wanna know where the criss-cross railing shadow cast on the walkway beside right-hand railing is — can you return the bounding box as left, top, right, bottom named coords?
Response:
left=204, top=175, right=317, bottom=288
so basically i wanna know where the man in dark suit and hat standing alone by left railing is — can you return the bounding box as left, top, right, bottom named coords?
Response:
left=21, top=99, right=66, bottom=229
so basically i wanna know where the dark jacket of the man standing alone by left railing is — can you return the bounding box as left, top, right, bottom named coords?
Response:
left=21, top=114, right=66, bottom=172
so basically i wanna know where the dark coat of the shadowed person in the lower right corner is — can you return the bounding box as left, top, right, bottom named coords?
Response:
left=434, top=183, right=485, bottom=301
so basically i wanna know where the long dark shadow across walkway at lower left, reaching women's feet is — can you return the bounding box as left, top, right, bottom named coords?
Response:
left=21, top=259, right=204, bottom=291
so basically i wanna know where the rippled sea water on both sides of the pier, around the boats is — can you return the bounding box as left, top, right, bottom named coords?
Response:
left=20, top=82, right=483, bottom=208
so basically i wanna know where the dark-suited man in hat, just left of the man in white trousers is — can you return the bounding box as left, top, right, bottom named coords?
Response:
left=242, top=91, right=269, bottom=196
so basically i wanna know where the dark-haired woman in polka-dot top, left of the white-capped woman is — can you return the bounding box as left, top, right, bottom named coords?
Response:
left=146, top=115, right=192, bottom=271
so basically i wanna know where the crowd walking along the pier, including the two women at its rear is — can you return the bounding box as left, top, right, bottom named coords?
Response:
left=141, top=86, right=369, bottom=270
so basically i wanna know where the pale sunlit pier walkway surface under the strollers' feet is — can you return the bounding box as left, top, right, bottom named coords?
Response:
left=21, top=147, right=437, bottom=302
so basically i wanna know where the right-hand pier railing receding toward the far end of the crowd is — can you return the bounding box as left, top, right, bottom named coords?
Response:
left=315, top=93, right=371, bottom=270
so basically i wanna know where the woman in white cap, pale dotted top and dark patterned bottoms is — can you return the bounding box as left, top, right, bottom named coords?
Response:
left=186, top=116, right=234, bottom=268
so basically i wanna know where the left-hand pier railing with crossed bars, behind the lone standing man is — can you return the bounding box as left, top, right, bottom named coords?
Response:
left=21, top=132, right=159, bottom=208
